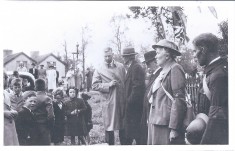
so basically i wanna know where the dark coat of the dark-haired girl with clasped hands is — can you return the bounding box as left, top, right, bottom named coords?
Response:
left=65, top=98, right=87, bottom=136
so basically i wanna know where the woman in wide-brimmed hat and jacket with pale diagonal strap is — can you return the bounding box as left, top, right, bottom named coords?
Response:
left=148, top=39, right=186, bottom=145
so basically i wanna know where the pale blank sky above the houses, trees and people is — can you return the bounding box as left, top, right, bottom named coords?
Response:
left=0, top=1, right=231, bottom=68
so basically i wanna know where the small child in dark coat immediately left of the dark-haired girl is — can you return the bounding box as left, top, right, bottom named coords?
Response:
left=51, top=88, right=65, bottom=145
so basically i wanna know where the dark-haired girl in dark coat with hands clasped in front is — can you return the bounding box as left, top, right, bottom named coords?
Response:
left=65, top=88, right=87, bottom=145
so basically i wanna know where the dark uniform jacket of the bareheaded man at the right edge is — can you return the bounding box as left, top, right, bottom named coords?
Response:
left=201, top=58, right=228, bottom=144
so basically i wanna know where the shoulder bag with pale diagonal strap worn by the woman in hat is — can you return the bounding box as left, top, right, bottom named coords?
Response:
left=161, top=82, right=195, bottom=130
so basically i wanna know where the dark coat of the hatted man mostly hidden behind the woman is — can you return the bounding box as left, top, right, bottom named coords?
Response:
left=141, top=68, right=162, bottom=145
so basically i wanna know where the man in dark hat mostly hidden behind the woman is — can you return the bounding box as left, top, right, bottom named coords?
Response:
left=141, top=50, right=162, bottom=145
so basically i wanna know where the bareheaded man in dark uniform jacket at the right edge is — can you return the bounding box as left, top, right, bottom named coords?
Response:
left=193, top=33, right=228, bottom=144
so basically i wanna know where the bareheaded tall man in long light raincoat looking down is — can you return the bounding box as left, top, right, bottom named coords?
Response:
left=92, top=47, right=125, bottom=145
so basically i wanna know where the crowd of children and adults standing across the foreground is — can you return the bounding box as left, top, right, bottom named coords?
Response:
left=4, top=33, right=228, bottom=145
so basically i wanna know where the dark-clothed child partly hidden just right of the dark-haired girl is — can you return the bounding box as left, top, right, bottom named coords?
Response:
left=81, top=93, right=93, bottom=144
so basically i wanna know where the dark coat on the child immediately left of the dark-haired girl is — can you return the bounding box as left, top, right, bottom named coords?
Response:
left=51, top=102, right=65, bottom=143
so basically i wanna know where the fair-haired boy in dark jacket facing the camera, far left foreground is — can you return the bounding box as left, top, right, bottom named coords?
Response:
left=16, top=91, right=37, bottom=145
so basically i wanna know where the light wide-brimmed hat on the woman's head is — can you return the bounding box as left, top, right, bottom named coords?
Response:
left=152, top=39, right=181, bottom=56
